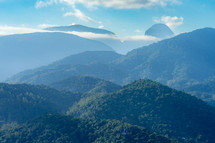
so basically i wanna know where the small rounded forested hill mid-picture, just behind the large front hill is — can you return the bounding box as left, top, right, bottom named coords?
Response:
left=50, top=76, right=121, bottom=93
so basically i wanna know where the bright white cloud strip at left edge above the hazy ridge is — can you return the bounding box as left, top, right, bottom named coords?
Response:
left=0, top=25, right=44, bottom=35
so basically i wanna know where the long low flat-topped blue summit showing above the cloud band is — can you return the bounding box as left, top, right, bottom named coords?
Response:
left=45, top=25, right=115, bottom=35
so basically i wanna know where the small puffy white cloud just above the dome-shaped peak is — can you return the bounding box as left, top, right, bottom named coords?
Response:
left=153, top=16, right=184, bottom=29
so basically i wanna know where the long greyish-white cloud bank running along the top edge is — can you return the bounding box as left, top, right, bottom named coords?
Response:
left=36, top=0, right=181, bottom=9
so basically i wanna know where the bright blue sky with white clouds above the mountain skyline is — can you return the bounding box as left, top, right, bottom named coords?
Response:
left=0, top=0, right=215, bottom=37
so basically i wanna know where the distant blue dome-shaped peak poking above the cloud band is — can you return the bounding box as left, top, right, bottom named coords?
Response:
left=145, top=23, right=174, bottom=39
